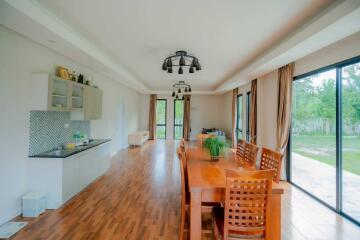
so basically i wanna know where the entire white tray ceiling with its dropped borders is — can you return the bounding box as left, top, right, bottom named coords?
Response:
left=0, top=0, right=360, bottom=94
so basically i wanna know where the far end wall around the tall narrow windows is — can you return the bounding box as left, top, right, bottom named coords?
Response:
left=139, top=94, right=226, bottom=139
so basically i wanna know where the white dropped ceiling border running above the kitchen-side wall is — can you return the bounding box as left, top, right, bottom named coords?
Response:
left=0, top=0, right=149, bottom=92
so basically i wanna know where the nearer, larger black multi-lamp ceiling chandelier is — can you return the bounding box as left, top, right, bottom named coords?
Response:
left=161, top=51, right=201, bottom=74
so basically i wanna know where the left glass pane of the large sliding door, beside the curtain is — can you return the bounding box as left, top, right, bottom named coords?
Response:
left=291, top=69, right=336, bottom=208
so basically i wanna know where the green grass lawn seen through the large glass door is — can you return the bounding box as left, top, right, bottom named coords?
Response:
left=291, top=135, right=360, bottom=175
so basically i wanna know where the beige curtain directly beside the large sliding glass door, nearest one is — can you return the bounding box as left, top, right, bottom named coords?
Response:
left=276, top=63, right=294, bottom=179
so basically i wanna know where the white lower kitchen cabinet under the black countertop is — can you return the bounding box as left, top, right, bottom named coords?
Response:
left=27, top=142, right=110, bottom=209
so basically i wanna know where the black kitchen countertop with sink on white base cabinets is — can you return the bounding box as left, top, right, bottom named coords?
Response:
left=29, top=139, right=111, bottom=158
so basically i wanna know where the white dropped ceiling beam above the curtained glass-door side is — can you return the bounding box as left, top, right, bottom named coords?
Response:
left=215, top=0, right=360, bottom=92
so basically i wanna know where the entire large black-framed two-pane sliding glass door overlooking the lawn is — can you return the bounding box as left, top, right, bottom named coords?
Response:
left=289, top=57, right=360, bottom=224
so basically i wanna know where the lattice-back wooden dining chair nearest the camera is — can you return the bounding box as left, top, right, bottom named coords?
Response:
left=214, top=170, right=274, bottom=240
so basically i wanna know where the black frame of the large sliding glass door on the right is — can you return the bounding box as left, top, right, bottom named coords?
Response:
left=286, top=56, right=360, bottom=226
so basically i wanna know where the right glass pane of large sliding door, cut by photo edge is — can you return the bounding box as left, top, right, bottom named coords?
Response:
left=341, top=63, right=360, bottom=222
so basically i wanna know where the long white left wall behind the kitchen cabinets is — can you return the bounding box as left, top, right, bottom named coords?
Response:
left=0, top=26, right=139, bottom=225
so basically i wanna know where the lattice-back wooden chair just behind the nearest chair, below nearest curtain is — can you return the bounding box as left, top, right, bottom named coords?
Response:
left=260, top=147, right=283, bottom=183
